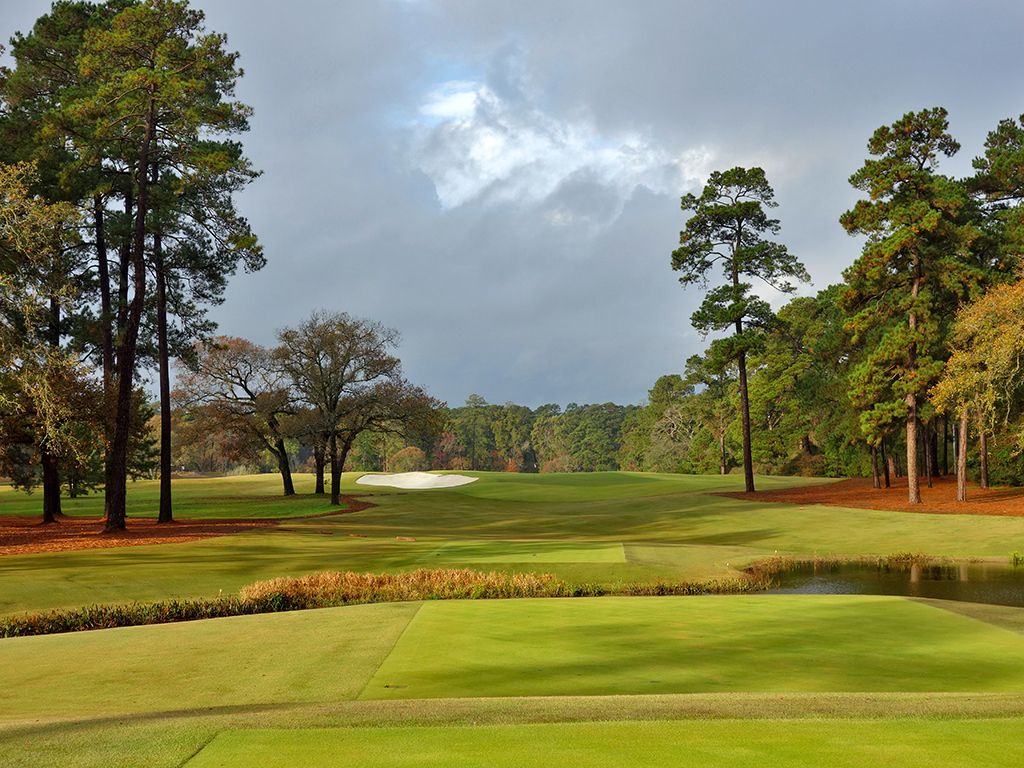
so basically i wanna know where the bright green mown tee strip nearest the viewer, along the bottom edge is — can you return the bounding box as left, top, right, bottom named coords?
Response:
left=185, top=720, right=1024, bottom=768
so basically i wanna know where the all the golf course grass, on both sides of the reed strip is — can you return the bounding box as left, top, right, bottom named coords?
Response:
left=6, top=473, right=1024, bottom=768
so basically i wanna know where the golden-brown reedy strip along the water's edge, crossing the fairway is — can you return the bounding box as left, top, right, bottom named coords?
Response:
left=0, top=568, right=768, bottom=637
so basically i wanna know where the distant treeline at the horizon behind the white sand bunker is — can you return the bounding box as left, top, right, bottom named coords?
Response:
left=174, top=393, right=640, bottom=483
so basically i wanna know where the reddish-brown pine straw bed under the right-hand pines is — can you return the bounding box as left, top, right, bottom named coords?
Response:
left=718, top=476, right=1024, bottom=517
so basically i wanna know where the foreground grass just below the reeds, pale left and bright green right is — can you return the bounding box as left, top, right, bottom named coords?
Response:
left=8, top=595, right=1024, bottom=722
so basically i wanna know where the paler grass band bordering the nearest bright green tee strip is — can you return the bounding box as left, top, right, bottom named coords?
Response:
left=6, top=693, right=1024, bottom=768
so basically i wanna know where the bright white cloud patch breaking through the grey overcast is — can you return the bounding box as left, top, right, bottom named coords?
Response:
left=411, top=80, right=714, bottom=218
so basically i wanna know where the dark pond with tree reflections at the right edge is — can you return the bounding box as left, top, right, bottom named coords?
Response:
left=768, top=562, right=1024, bottom=606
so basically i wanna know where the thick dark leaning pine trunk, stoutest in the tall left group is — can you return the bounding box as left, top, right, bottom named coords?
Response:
left=103, top=96, right=156, bottom=532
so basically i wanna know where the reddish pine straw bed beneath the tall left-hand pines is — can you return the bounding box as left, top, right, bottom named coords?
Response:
left=0, top=496, right=374, bottom=556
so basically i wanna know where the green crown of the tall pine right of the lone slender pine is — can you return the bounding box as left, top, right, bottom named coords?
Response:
left=840, top=108, right=987, bottom=442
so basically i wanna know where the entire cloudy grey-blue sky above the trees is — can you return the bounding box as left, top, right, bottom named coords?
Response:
left=0, top=0, right=1024, bottom=406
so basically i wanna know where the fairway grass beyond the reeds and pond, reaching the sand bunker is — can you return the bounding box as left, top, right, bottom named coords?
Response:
left=0, top=472, right=1024, bottom=614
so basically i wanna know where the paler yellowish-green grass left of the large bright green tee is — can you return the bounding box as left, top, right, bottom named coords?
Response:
left=0, top=603, right=419, bottom=721
